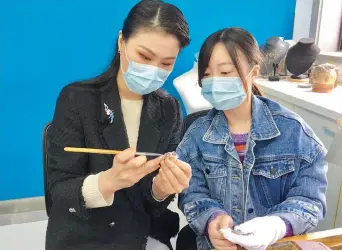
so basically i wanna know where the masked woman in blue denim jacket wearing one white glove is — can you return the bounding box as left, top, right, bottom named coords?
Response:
left=177, top=28, right=328, bottom=249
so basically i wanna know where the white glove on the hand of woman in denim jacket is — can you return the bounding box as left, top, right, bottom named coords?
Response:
left=220, top=216, right=286, bottom=250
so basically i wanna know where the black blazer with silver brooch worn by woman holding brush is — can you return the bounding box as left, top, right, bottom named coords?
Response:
left=46, top=74, right=182, bottom=249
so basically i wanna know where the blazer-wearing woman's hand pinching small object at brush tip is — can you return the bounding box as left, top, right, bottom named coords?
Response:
left=152, top=157, right=192, bottom=200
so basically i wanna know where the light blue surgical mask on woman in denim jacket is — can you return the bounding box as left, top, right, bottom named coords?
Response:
left=201, top=68, right=254, bottom=110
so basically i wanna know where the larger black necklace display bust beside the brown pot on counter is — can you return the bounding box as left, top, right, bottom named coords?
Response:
left=285, top=38, right=320, bottom=79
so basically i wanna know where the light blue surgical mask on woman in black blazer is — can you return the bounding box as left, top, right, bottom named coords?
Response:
left=121, top=48, right=171, bottom=95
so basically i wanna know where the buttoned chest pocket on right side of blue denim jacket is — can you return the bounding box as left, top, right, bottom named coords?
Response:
left=252, top=160, right=295, bottom=207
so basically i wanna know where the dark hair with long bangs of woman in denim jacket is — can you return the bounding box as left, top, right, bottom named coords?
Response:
left=198, top=28, right=262, bottom=96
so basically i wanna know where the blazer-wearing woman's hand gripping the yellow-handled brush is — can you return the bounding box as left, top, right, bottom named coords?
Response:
left=99, top=148, right=163, bottom=198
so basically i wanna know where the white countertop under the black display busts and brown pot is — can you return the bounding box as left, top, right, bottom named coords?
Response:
left=255, top=79, right=342, bottom=120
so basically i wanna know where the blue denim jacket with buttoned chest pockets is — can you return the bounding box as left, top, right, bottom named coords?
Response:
left=177, top=96, right=328, bottom=249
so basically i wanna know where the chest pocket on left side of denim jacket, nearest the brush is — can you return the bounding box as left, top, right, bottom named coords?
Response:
left=202, top=156, right=228, bottom=205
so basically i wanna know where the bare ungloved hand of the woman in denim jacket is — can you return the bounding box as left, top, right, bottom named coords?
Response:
left=208, top=214, right=237, bottom=250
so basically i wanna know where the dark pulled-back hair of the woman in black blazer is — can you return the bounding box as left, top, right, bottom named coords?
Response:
left=102, top=0, right=190, bottom=79
